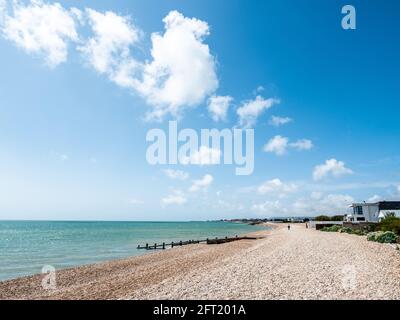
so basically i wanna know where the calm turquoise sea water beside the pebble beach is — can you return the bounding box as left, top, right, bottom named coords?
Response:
left=0, top=221, right=265, bottom=280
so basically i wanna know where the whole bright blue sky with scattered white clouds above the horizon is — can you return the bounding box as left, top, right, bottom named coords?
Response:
left=0, top=0, right=400, bottom=220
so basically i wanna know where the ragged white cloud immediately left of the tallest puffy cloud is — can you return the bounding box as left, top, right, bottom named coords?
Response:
left=78, top=9, right=141, bottom=88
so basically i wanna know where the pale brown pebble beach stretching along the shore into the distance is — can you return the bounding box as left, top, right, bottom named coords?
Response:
left=0, top=223, right=400, bottom=299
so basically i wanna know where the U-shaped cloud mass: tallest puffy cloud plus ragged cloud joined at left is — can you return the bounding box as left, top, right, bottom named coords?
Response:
left=79, top=9, right=218, bottom=120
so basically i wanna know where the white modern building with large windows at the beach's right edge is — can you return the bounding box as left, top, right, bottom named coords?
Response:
left=344, top=201, right=400, bottom=222
